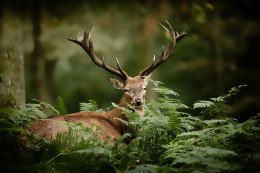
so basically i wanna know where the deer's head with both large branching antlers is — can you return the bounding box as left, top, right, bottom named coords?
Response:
left=68, top=21, right=187, bottom=111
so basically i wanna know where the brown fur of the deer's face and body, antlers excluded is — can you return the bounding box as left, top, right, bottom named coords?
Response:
left=22, top=77, right=146, bottom=142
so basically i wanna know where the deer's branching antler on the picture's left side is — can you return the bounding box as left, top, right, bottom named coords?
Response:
left=68, top=25, right=128, bottom=81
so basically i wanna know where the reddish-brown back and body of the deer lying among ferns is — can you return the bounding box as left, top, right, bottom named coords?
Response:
left=27, top=109, right=127, bottom=142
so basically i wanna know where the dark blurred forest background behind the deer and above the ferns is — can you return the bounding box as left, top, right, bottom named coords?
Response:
left=0, top=0, right=260, bottom=120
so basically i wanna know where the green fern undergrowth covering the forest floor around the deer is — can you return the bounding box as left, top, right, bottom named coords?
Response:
left=0, top=82, right=260, bottom=173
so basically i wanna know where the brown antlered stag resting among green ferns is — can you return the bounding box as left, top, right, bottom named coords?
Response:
left=22, top=21, right=187, bottom=143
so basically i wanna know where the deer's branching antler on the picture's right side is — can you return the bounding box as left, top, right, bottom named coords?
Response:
left=139, top=20, right=187, bottom=77
